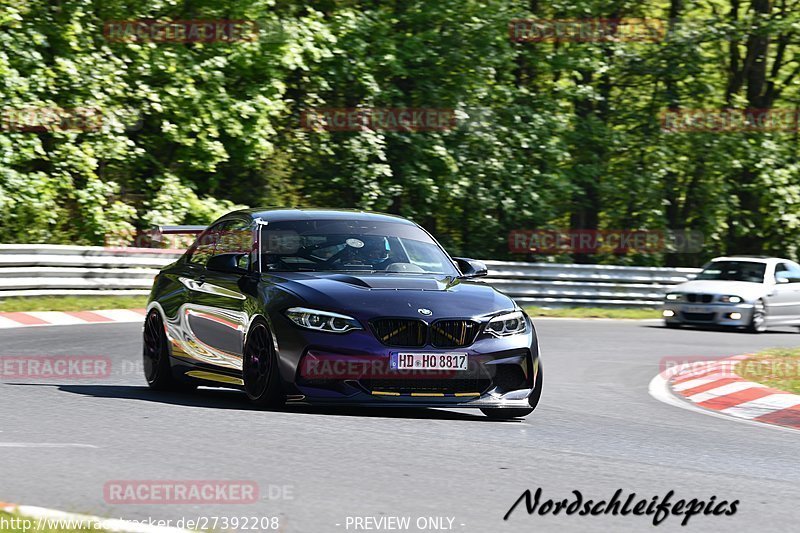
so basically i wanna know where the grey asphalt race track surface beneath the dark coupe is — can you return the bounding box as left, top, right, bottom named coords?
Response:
left=0, top=320, right=800, bottom=533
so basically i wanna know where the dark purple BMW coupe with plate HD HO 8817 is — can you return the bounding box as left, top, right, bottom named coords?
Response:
left=144, top=209, right=542, bottom=418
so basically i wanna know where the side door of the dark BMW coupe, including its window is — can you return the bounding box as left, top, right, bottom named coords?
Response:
left=185, top=218, right=253, bottom=370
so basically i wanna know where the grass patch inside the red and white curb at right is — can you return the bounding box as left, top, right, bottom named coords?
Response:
left=735, top=348, right=800, bottom=394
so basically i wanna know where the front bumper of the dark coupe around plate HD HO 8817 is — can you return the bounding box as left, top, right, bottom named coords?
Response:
left=275, top=308, right=539, bottom=408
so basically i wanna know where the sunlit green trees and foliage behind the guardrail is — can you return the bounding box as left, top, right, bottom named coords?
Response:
left=0, top=0, right=800, bottom=265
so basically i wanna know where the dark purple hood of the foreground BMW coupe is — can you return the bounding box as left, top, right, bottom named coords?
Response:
left=263, top=272, right=514, bottom=320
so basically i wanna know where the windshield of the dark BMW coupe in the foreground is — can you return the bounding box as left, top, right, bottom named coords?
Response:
left=260, top=220, right=459, bottom=276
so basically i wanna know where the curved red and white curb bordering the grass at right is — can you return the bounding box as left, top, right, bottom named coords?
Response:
left=649, top=355, right=800, bottom=430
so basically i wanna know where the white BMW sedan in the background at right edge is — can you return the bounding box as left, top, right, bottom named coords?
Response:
left=662, top=257, right=800, bottom=333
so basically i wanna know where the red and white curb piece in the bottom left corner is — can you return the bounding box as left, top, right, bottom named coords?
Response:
left=0, top=502, right=190, bottom=533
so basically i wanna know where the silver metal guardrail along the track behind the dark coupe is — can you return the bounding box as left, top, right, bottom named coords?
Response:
left=0, top=244, right=699, bottom=307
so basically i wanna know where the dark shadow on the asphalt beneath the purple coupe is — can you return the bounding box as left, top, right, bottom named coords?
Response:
left=8, top=383, right=506, bottom=422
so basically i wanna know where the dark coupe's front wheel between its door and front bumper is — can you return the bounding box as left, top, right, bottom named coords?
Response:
left=242, top=319, right=286, bottom=408
